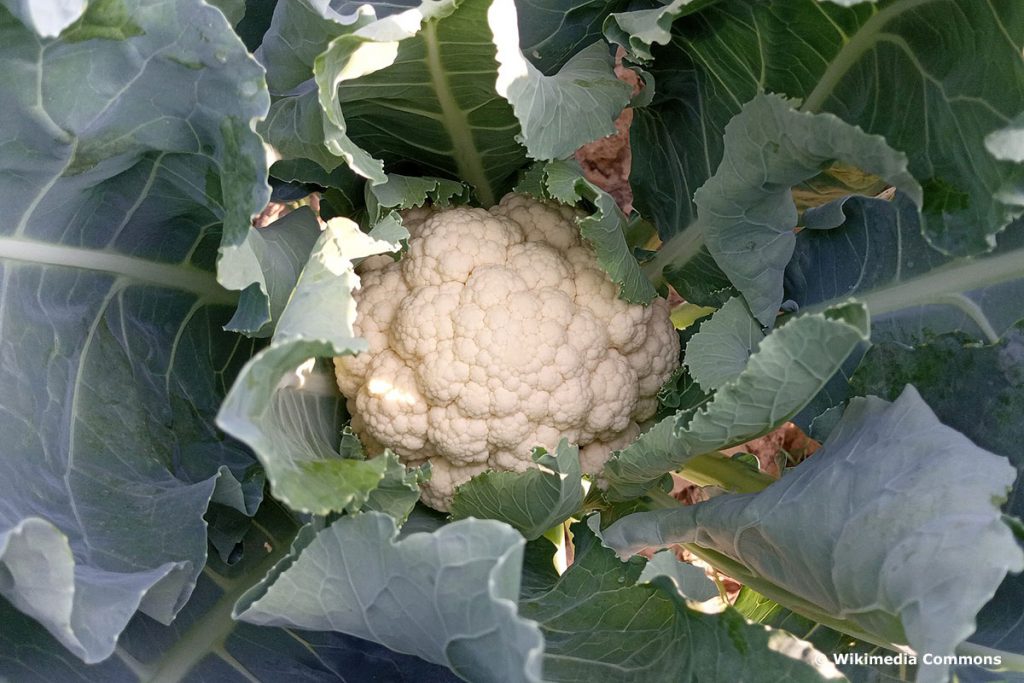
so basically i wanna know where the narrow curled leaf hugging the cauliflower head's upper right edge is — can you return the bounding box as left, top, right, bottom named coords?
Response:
left=544, top=162, right=657, bottom=303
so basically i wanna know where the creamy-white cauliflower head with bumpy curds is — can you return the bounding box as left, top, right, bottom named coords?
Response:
left=335, top=195, right=679, bottom=510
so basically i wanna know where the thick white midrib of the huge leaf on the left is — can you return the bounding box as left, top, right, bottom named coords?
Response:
left=0, top=238, right=238, bottom=305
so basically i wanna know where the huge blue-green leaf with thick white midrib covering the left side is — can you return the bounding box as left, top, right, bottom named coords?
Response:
left=0, top=0, right=268, bottom=661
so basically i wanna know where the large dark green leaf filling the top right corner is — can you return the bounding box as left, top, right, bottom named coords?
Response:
left=620, top=0, right=1024, bottom=254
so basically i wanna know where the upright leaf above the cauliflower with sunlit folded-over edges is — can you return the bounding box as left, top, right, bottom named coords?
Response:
left=261, top=0, right=629, bottom=206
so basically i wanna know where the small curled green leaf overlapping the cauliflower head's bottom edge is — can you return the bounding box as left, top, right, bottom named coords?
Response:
left=452, top=439, right=584, bottom=541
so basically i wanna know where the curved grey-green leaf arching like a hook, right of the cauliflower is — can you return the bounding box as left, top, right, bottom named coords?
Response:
left=693, top=95, right=921, bottom=326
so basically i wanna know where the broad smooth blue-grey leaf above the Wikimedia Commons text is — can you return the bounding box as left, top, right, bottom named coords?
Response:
left=603, top=387, right=1024, bottom=680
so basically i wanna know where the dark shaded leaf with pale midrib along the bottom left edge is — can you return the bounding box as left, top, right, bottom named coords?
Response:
left=0, top=501, right=458, bottom=683
